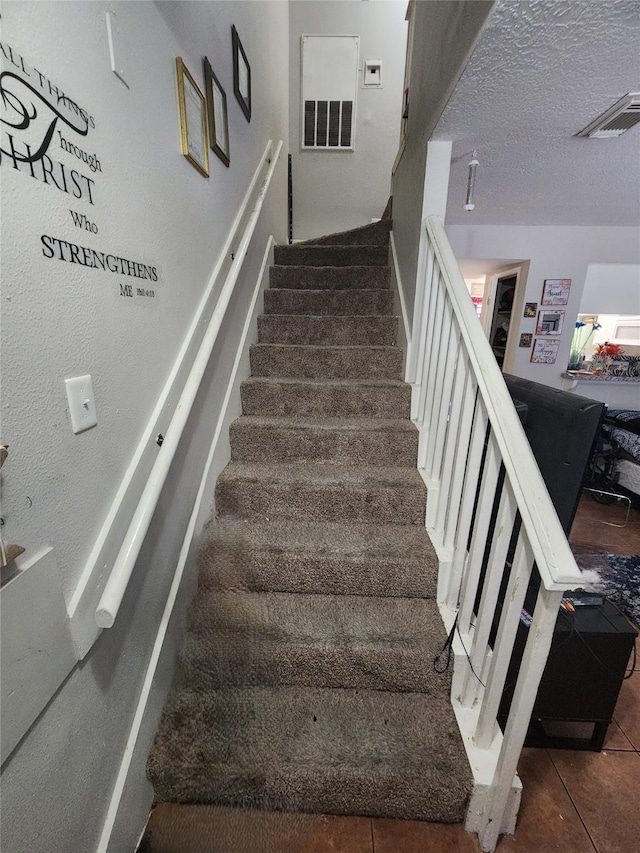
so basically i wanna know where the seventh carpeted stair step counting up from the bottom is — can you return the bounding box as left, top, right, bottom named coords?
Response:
left=250, top=344, right=403, bottom=379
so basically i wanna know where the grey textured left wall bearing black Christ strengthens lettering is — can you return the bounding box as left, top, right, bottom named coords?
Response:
left=0, top=2, right=288, bottom=853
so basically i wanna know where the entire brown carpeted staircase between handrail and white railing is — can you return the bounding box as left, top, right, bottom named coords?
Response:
left=148, top=221, right=471, bottom=821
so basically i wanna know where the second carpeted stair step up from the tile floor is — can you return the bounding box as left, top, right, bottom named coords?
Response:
left=182, top=590, right=450, bottom=694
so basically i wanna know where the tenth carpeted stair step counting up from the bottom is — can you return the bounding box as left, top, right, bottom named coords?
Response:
left=269, top=265, right=391, bottom=290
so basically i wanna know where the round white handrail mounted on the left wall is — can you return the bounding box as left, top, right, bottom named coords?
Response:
left=95, top=140, right=283, bottom=628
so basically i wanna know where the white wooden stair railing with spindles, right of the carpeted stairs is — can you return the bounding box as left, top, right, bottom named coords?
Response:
left=413, top=216, right=581, bottom=851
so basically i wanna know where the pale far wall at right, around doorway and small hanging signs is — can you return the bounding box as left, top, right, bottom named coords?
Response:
left=447, top=225, right=640, bottom=402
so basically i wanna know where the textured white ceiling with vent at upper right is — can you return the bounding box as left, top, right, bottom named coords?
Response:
left=433, top=0, right=640, bottom=225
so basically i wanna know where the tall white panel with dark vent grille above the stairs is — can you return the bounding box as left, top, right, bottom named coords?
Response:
left=301, top=36, right=360, bottom=151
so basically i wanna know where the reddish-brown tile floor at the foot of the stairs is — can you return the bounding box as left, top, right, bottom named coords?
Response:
left=140, top=495, right=640, bottom=853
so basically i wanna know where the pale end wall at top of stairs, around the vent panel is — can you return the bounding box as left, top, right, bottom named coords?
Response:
left=289, top=0, right=407, bottom=239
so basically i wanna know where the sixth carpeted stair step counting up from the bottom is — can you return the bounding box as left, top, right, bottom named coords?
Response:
left=240, top=376, right=411, bottom=418
